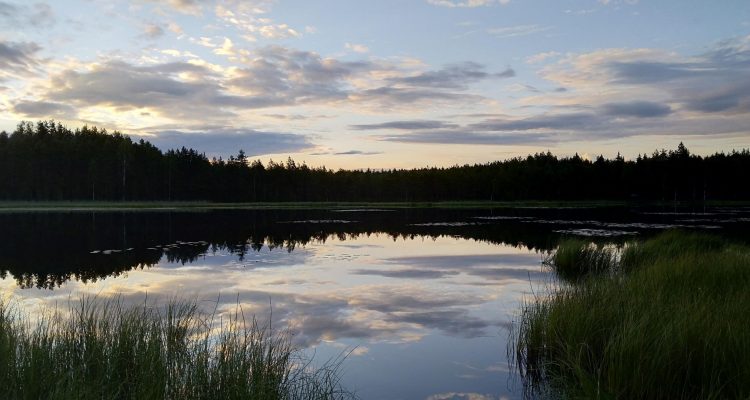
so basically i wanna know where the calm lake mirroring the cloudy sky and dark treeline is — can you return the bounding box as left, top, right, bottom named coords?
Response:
left=0, top=207, right=750, bottom=400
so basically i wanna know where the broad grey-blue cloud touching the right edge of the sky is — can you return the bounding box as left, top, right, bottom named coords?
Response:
left=543, top=36, right=750, bottom=115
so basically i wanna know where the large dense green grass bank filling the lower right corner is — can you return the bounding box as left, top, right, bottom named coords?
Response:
left=514, top=232, right=750, bottom=399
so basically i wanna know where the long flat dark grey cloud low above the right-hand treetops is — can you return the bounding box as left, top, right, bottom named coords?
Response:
left=368, top=88, right=736, bottom=145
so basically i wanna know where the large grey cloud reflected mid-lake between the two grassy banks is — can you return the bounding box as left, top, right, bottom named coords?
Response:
left=178, top=278, right=501, bottom=346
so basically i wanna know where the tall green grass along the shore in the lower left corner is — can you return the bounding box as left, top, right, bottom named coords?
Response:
left=0, top=298, right=353, bottom=399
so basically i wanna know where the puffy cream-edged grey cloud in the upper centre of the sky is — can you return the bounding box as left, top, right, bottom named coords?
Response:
left=227, top=46, right=500, bottom=106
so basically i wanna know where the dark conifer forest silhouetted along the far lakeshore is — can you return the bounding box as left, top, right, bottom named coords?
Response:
left=0, top=121, right=750, bottom=202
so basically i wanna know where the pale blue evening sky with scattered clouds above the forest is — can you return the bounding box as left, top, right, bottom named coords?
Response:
left=0, top=0, right=750, bottom=168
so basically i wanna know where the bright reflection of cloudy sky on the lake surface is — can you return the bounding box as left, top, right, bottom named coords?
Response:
left=0, top=235, right=545, bottom=398
